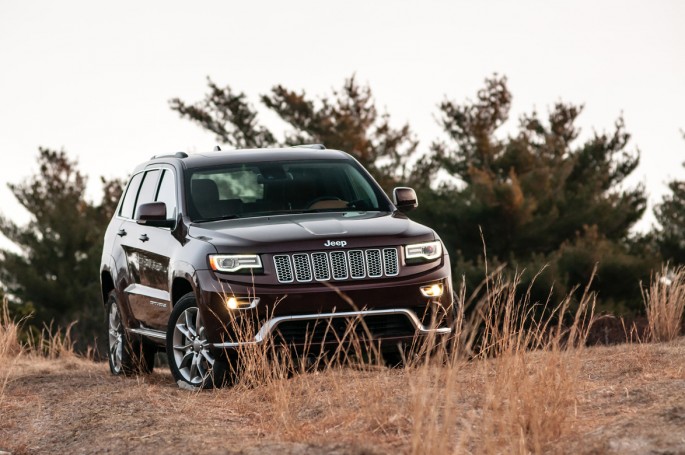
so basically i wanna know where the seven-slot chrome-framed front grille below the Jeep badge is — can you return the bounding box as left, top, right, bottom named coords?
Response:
left=274, top=248, right=400, bottom=283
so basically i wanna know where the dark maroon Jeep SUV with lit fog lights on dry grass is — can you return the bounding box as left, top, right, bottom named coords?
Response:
left=100, top=146, right=452, bottom=387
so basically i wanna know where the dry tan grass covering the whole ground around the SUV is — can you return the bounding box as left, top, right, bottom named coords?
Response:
left=0, top=275, right=685, bottom=454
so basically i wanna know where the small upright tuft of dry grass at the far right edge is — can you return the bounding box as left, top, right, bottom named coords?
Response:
left=643, top=266, right=685, bottom=341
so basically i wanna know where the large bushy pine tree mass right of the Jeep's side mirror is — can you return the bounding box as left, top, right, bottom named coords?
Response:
left=416, top=76, right=657, bottom=310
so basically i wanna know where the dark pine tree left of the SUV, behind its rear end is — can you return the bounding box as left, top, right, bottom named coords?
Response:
left=0, top=148, right=121, bottom=348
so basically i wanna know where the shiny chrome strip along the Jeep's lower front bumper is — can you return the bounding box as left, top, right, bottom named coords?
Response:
left=212, top=308, right=452, bottom=348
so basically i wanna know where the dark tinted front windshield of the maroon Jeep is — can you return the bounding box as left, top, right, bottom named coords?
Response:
left=186, top=160, right=390, bottom=221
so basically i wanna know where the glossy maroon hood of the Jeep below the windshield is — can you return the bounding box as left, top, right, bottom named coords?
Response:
left=189, top=212, right=436, bottom=253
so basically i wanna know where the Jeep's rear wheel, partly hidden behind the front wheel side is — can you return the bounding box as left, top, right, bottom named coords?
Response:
left=105, top=291, right=157, bottom=376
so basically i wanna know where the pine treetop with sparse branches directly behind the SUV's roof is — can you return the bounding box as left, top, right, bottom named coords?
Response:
left=169, top=76, right=418, bottom=191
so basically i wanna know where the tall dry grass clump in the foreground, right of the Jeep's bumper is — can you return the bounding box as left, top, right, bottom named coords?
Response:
left=404, top=268, right=595, bottom=454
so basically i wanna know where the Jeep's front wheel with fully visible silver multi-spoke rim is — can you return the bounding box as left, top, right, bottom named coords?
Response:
left=166, top=293, right=230, bottom=389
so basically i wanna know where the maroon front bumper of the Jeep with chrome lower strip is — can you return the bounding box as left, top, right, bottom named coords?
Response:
left=196, top=253, right=454, bottom=350
